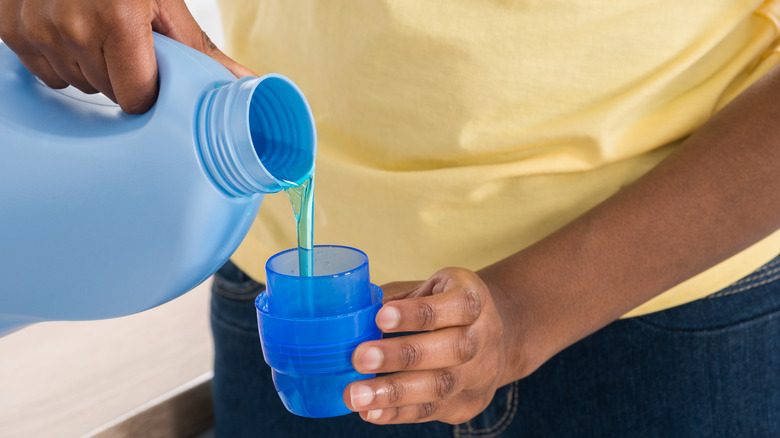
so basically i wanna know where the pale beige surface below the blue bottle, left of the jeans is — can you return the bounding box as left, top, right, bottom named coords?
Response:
left=0, top=281, right=213, bottom=438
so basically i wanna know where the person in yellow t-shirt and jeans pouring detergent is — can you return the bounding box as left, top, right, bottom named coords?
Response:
left=0, top=0, right=780, bottom=437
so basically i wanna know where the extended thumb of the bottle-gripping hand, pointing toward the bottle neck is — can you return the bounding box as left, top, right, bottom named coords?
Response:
left=152, top=0, right=256, bottom=78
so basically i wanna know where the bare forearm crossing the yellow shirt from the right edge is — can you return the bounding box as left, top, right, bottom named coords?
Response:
left=479, top=62, right=780, bottom=383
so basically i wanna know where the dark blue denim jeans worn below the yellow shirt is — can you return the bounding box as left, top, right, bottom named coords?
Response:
left=211, top=257, right=780, bottom=438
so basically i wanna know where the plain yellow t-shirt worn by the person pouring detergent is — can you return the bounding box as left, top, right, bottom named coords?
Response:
left=221, top=0, right=780, bottom=315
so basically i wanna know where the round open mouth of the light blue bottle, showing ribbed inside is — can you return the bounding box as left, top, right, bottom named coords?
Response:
left=248, top=75, right=316, bottom=186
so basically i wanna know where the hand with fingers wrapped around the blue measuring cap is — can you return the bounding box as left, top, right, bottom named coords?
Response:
left=344, top=268, right=504, bottom=424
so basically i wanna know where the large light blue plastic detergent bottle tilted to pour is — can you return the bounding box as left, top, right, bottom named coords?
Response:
left=0, top=35, right=316, bottom=336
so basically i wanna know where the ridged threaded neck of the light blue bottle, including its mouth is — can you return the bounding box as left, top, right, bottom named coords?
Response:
left=197, top=74, right=317, bottom=196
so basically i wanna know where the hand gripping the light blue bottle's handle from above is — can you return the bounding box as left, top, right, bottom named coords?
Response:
left=0, top=0, right=252, bottom=113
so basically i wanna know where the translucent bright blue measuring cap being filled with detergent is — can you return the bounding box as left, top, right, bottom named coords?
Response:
left=255, top=246, right=382, bottom=418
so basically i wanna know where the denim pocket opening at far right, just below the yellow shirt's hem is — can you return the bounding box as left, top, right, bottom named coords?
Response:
left=630, top=257, right=780, bottom=332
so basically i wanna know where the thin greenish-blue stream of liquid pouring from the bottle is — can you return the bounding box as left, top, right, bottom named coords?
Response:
left=285, top=174, right=314, bottom=277
